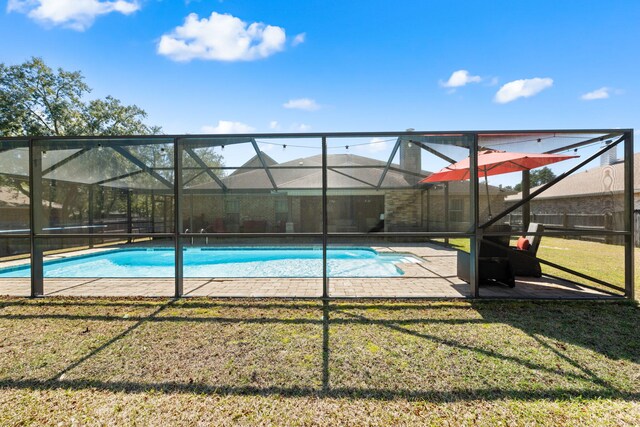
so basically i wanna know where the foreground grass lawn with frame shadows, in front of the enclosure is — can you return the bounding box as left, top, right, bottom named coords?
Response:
left=0, top=298, right=640, bottom=426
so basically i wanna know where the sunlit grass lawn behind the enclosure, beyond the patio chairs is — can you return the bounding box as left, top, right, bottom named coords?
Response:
left=449, top=236, right=640, bottom=299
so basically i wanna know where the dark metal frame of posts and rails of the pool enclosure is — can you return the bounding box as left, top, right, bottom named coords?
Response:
left=2, top=129, right=635, bottom=299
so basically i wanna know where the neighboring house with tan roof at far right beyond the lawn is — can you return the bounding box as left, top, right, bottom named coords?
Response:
left=505, top=153, right=640, bottom=234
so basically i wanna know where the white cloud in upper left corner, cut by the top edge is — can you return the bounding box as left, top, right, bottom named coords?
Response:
left=7, top=0, right=140, bottom=31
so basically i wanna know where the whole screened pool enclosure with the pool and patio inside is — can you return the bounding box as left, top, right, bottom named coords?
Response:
left=0, top=129, right=640, bottom=298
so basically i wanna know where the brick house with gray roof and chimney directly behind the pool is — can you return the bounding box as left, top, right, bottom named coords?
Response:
left=183, top=143, right=505, bottom=233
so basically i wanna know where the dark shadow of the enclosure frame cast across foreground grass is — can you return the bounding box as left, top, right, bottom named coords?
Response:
left=0, top=300, right=640, bottom=402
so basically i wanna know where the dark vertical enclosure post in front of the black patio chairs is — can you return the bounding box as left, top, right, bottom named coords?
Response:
left=468, top=134, right=482, bottom=298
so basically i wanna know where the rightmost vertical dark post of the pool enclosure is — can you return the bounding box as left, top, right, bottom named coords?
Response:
left=624, top=132, right=635, bottom=300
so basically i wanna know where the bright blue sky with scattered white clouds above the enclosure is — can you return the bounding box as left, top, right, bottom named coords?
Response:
left=0, top=0, right=640, bottom=139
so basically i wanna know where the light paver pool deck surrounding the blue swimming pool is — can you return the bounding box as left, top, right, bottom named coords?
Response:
left=0, top=243, right=618, bottom=299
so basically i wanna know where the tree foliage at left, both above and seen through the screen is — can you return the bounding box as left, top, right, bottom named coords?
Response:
left=0, top=57, right=222, bottom=225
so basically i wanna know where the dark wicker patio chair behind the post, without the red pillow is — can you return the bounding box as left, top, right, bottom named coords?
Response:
left=457, top=224, right=516, bottom=288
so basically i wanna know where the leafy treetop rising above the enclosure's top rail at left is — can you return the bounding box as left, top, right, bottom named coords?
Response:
left=0, top=57, right=161, bottom=136
